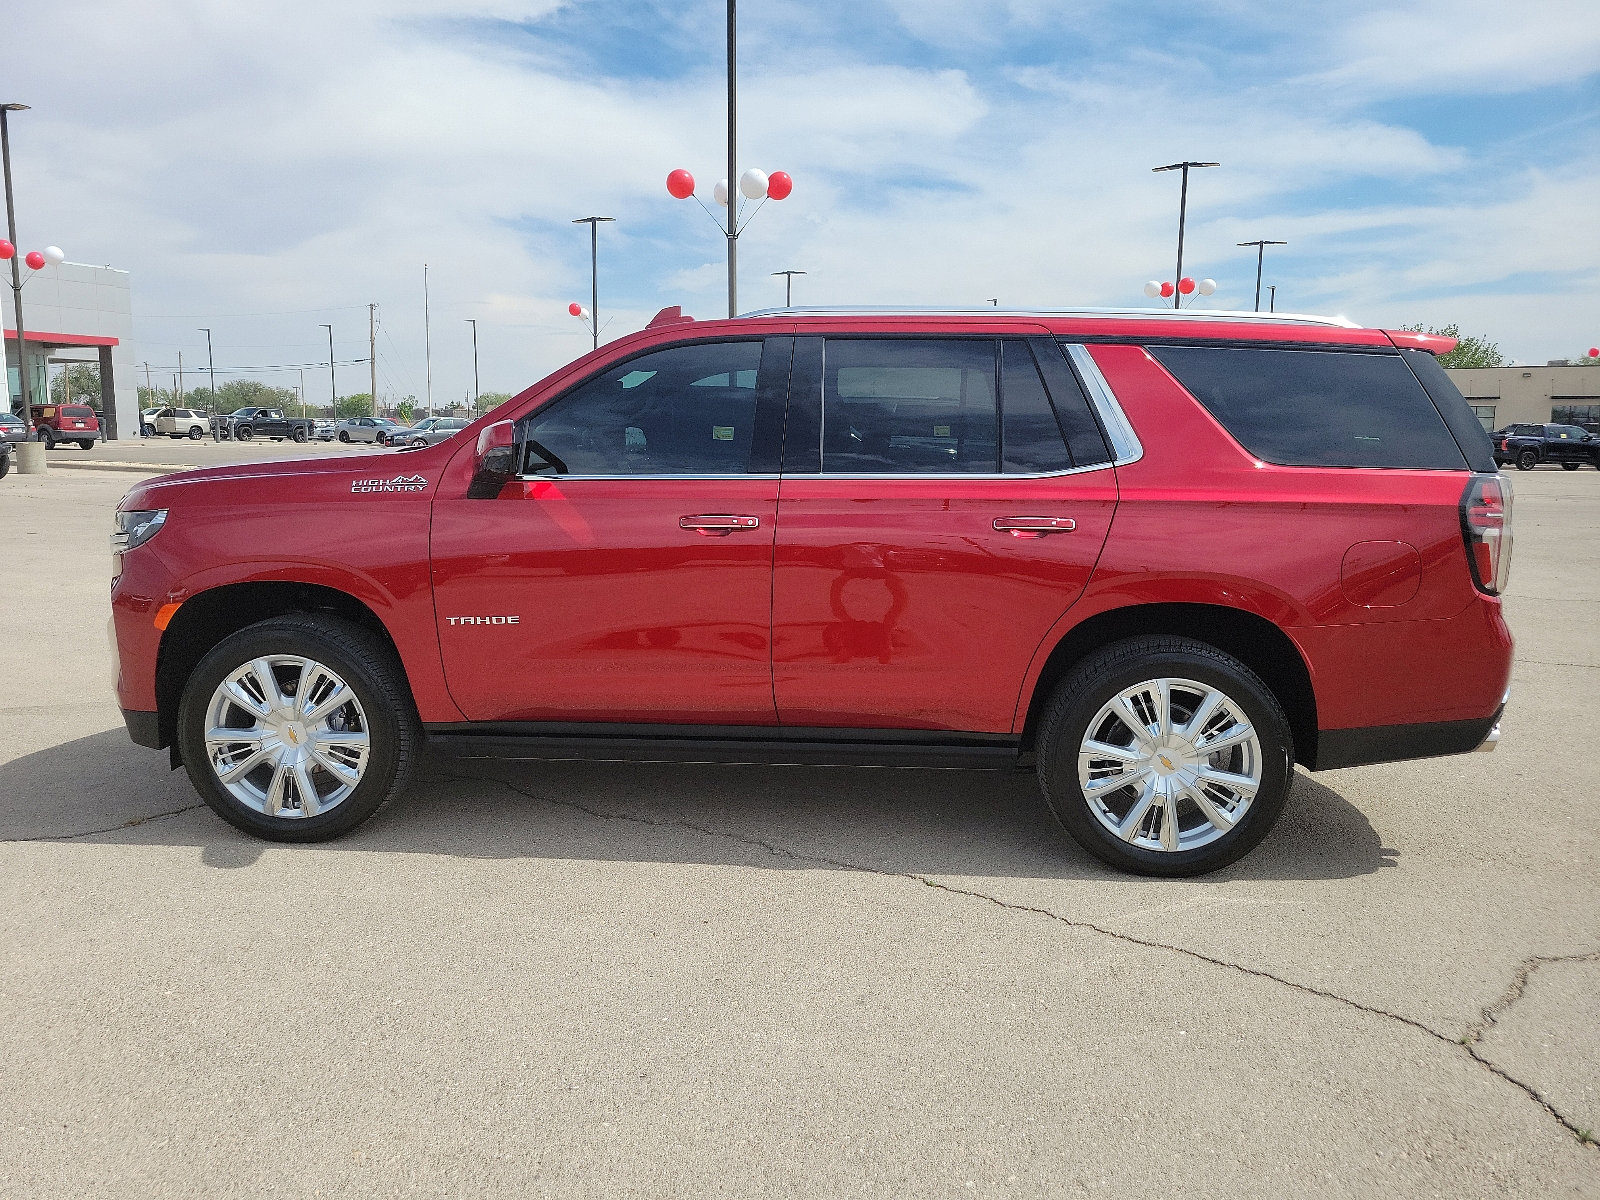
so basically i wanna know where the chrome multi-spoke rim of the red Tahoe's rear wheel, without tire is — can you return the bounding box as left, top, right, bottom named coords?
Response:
left=1078, top=678, right=1262, bottom=853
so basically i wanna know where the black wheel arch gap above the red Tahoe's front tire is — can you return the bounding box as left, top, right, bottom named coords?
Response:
left=155, top=579, right=406, bottom=766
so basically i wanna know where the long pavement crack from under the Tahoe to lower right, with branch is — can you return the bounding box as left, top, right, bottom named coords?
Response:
left=457, top=774, right=1600, bottom=1149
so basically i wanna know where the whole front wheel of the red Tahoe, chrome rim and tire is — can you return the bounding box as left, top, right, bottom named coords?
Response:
left=178, top=614, right=421, bottom=842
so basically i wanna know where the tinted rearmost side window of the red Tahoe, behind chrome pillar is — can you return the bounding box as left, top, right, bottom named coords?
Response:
left=1149, top=346, right=1467, bottom=470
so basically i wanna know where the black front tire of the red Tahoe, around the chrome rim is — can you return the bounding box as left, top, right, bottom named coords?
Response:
left=178, top=613, right=422, bottom=842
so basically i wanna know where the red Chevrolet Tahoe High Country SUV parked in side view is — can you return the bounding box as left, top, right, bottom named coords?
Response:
left=112, top=309, right=1512, bottom=875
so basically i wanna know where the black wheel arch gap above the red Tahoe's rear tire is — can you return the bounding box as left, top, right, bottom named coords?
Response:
left=1022, top=603, right=1317, bottom=768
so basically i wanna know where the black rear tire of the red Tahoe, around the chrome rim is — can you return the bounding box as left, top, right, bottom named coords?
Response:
left=1037, top=635, right=1294, bottom=877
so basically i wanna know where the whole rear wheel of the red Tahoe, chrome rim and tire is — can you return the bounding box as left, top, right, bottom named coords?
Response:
left=1038, top=637, right=1294, bottom=875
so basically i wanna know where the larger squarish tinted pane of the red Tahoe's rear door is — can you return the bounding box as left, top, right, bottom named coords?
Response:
left=822, top=338, right=998, bottom=475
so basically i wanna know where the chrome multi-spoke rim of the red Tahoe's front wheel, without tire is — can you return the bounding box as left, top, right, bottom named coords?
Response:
left=205, top=654, right=371, bottom=819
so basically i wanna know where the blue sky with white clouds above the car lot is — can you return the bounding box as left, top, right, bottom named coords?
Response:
left=0, top=0, right=1600, bottom=403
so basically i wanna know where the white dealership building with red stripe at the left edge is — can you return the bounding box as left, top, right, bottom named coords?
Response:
left=0, top=262, right=139, bottom=440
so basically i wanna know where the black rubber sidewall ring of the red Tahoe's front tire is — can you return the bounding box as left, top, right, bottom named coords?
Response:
left=178, top=621, right=405, bottom=842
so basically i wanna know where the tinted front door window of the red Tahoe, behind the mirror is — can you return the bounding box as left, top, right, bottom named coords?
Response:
left=522, top=341, right=762, bottom=475
